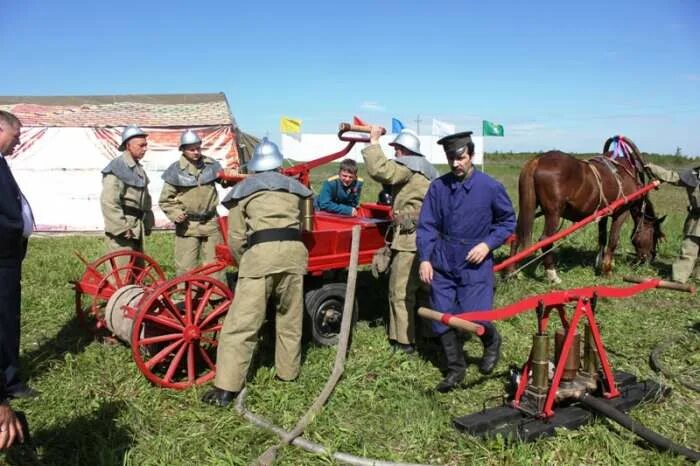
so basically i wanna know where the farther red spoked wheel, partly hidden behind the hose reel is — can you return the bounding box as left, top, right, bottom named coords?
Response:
left=75, top=250, right=165, bottom=332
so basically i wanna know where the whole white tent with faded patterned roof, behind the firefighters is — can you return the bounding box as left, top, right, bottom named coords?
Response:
left=0, top=94, right=249, bottom=231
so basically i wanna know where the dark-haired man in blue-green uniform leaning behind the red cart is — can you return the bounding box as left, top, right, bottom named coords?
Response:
left=315, top=159, right=362, bottom=217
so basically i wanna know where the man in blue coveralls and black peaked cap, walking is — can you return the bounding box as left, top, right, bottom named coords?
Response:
left=417, top=131, right=515, bottom=393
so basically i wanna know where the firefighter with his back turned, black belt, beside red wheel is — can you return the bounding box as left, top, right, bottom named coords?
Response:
left=203, top=138, right=313, bottom=406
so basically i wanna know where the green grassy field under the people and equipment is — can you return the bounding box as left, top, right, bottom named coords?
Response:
left=0, top=155, right=700, bottom=465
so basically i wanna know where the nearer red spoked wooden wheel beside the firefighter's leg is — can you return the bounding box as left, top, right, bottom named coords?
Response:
left=131, top=275, right=233, bottom=390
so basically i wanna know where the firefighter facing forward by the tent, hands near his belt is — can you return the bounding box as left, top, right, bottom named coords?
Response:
left=158, top=130, right=225, bottom=280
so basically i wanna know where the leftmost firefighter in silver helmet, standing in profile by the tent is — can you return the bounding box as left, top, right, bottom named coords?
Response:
left=100, top=125, right=154, bottom=265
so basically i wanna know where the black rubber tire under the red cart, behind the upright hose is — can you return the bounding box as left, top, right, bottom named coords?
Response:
left=304, top=283, right=359, bottom=346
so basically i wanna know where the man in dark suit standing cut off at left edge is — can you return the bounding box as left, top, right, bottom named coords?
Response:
left=0, top=110, right=36, bottom=398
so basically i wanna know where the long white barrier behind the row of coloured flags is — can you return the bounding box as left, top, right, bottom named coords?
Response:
left=281, top=133, right=484, bottom=165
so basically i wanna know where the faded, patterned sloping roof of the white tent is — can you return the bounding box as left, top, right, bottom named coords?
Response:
left=0, top=92, right=235, bottom=127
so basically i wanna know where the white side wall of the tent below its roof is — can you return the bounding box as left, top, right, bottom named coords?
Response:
left=8, top=126, right=234, bottom=231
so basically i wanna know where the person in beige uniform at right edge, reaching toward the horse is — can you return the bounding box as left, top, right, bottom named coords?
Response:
left=646, top=163, right=700, bottom=283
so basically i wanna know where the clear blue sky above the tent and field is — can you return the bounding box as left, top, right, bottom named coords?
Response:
left=0, top=0, right=700, bottom=156
